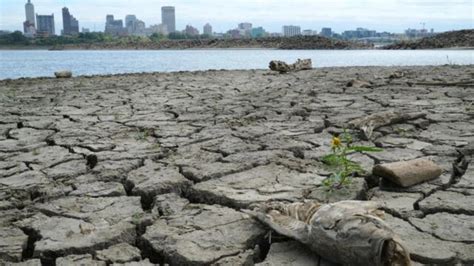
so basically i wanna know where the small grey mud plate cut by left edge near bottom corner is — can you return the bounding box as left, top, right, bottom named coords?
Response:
left=0, top=227, right=28, bottom=262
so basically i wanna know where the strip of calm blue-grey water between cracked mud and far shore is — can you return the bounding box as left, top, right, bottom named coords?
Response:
left=0, top=49, right=474, bottom=79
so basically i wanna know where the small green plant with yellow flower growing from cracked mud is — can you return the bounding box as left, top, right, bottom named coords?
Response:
left=322, top=130, right=382, bottom=191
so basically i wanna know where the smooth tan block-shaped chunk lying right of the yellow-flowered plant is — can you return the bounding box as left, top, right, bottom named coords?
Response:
left=372, top=159, right=442, bottom=187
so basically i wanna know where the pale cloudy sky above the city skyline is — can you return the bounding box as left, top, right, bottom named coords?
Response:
left=0, top=0, right=474, bottom=34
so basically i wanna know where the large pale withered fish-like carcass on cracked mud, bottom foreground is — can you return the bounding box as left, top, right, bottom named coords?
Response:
left=245, top=201, right=411, bottom=266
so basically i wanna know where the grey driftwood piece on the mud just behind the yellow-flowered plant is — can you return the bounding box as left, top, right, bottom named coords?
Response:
left=349, top=111, right=426, bottom=140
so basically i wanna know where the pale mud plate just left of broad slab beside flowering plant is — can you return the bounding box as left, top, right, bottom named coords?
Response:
left=127, top=160, right=192, bottom=204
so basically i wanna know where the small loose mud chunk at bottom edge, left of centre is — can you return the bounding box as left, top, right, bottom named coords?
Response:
left=96, top=243, right=142, bottom=264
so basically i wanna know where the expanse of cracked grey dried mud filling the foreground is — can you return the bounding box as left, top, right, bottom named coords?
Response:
left=0, top=66, right=474, bottom=265
